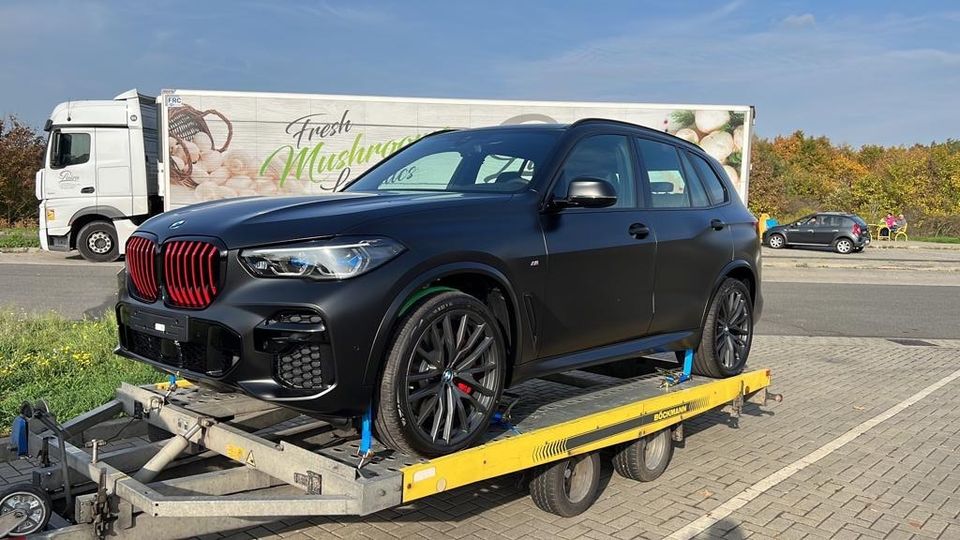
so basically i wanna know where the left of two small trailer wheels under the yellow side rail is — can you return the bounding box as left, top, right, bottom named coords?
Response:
left=530, top=452, right=600, bottom=517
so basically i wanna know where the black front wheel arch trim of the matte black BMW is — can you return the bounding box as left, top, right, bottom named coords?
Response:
left=363, top=262, right=523, bottom=386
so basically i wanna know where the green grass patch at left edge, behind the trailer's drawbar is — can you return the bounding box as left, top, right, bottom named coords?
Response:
left=0, top=311, right=164, bottom=433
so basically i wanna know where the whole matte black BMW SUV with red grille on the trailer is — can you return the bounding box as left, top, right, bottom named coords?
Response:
left=117, top=120, right=762, bottom=455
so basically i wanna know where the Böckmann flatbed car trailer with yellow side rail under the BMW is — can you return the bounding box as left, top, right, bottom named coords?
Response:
left=0, top=352, right=780, bottom=539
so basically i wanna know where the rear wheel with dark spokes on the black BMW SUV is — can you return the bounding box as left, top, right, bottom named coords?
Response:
left=693, top=278, right=753, bottom=378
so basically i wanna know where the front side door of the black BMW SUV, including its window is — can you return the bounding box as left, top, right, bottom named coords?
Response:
left=538, top=133, right=656, bottom=357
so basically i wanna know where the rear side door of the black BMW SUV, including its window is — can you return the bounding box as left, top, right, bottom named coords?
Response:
left=636, top=137, right=733, bottom=334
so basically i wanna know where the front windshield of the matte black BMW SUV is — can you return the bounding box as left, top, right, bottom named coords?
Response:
left=345, top=129, right=562, bottom=193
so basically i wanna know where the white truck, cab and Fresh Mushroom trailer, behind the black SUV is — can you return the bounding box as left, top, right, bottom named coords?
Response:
left=37, top=90, right=754, bottom=260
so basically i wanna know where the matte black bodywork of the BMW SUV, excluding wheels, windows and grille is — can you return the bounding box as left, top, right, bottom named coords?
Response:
left=117, top=120, right=762, bottom=417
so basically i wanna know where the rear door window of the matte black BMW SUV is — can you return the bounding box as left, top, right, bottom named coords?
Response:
left=637, top=139, right=692, bottom=208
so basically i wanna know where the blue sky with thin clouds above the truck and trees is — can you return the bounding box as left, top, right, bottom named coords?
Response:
left=0, top=0, right=960, bottom=145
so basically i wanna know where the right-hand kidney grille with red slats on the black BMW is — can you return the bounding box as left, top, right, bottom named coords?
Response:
left=163, top=241, right=220, bottom=309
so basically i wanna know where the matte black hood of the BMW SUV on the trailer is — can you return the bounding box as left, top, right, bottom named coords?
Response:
left=138, top=192, right=510, bottom=249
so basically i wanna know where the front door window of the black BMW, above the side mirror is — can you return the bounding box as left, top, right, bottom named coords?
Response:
left=553, top=135, right=637, bottom=208
